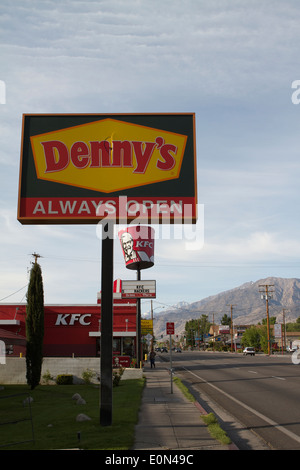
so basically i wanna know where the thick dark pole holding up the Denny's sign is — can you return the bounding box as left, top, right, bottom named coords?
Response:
left=100, top=222, right=114, bottom=426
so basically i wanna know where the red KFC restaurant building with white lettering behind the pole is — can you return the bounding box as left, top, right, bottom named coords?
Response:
left=0, top=280, right=136, bottom=367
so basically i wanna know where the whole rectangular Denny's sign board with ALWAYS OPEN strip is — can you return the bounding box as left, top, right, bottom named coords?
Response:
left=18, top=113, right=197, bottom=224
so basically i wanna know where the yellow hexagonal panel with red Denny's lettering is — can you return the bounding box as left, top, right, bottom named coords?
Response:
left=30, top=119, right=187, bottom=193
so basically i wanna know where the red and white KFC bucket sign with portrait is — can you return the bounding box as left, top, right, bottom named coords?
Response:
left=119, top=225, right=154, bottom=270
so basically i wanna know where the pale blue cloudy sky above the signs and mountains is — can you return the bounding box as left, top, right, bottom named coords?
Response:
left=0, top=0, right=300, bottom=312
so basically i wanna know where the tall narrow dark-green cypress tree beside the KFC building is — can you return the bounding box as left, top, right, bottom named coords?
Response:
left=26, top=261, right=44, bottom=390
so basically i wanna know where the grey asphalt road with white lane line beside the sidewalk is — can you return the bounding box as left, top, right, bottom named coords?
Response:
left=158, top=351, right=300, bottom=450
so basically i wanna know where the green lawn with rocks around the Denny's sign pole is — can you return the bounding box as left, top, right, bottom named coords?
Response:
left=0, top=379, right=144, bottom=450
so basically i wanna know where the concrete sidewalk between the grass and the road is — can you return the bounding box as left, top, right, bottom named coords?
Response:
left=132, top=361, right=236, bottom=451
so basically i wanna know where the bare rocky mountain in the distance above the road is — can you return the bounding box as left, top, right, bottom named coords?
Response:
left=154, top=277, right=300, bottom=339
